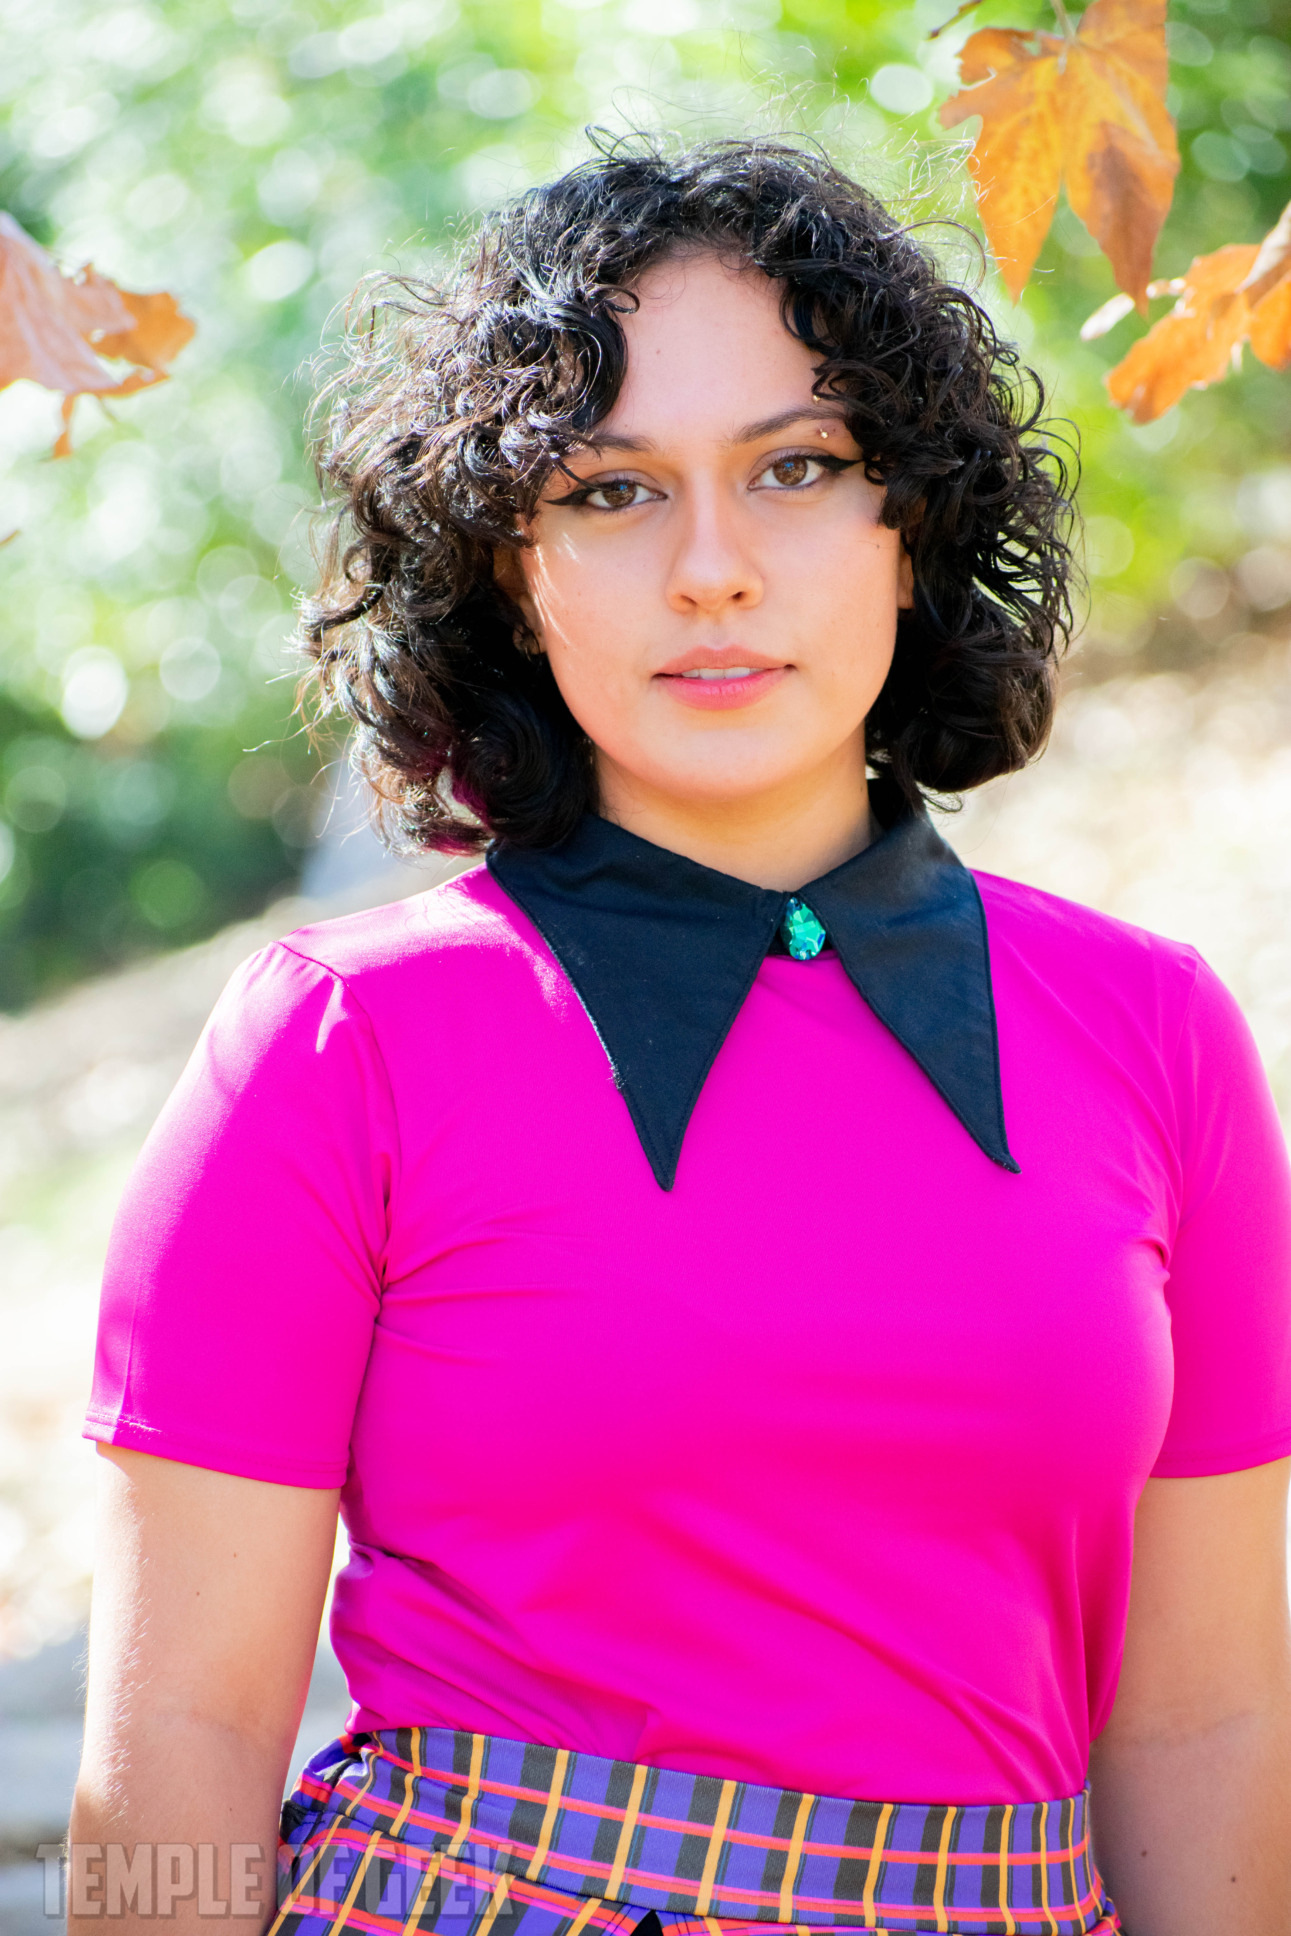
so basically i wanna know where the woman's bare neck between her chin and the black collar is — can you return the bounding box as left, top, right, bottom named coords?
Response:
left=596, top=755, right=875, bottom=892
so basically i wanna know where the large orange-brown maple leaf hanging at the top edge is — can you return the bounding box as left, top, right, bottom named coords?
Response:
left=941, top=0, right=1179, bottom=312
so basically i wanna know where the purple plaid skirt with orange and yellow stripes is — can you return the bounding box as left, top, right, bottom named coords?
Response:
left=271, top=1727, right=1121, bottom=1936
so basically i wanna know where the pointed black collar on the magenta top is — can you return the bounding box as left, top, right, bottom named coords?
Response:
left=488, top=782, right=1018, bottom=1191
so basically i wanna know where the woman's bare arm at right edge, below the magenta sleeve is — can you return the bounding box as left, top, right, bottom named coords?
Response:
left=1092, top=1460, right=1291, bottom=1936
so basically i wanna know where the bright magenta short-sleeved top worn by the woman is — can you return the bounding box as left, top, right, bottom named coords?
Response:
left=89, top=869, right=1291, bottom=1802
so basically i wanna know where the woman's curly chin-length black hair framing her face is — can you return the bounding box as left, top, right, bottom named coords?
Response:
left=302, top=137, right=1074, bottom=852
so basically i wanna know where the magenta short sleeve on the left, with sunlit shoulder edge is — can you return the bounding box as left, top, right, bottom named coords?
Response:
left=85, top=943, right=397, bottom=1487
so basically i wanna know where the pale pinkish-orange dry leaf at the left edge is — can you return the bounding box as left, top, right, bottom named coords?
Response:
left=0, top=211, right=194, bottom=457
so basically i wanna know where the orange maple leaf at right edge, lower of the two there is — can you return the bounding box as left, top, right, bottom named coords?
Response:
left=1086, top=203, right=1291, bottom=424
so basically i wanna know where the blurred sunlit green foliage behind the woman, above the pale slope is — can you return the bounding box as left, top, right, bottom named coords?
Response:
left=0, top=0, right=1291, bottom=1007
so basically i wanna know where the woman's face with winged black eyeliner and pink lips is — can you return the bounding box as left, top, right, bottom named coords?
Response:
left=499, top=256, right=910, bottom=825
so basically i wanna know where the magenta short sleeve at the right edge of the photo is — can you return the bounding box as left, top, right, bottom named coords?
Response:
left=1154, top=964, right=1291, bottom=1479
